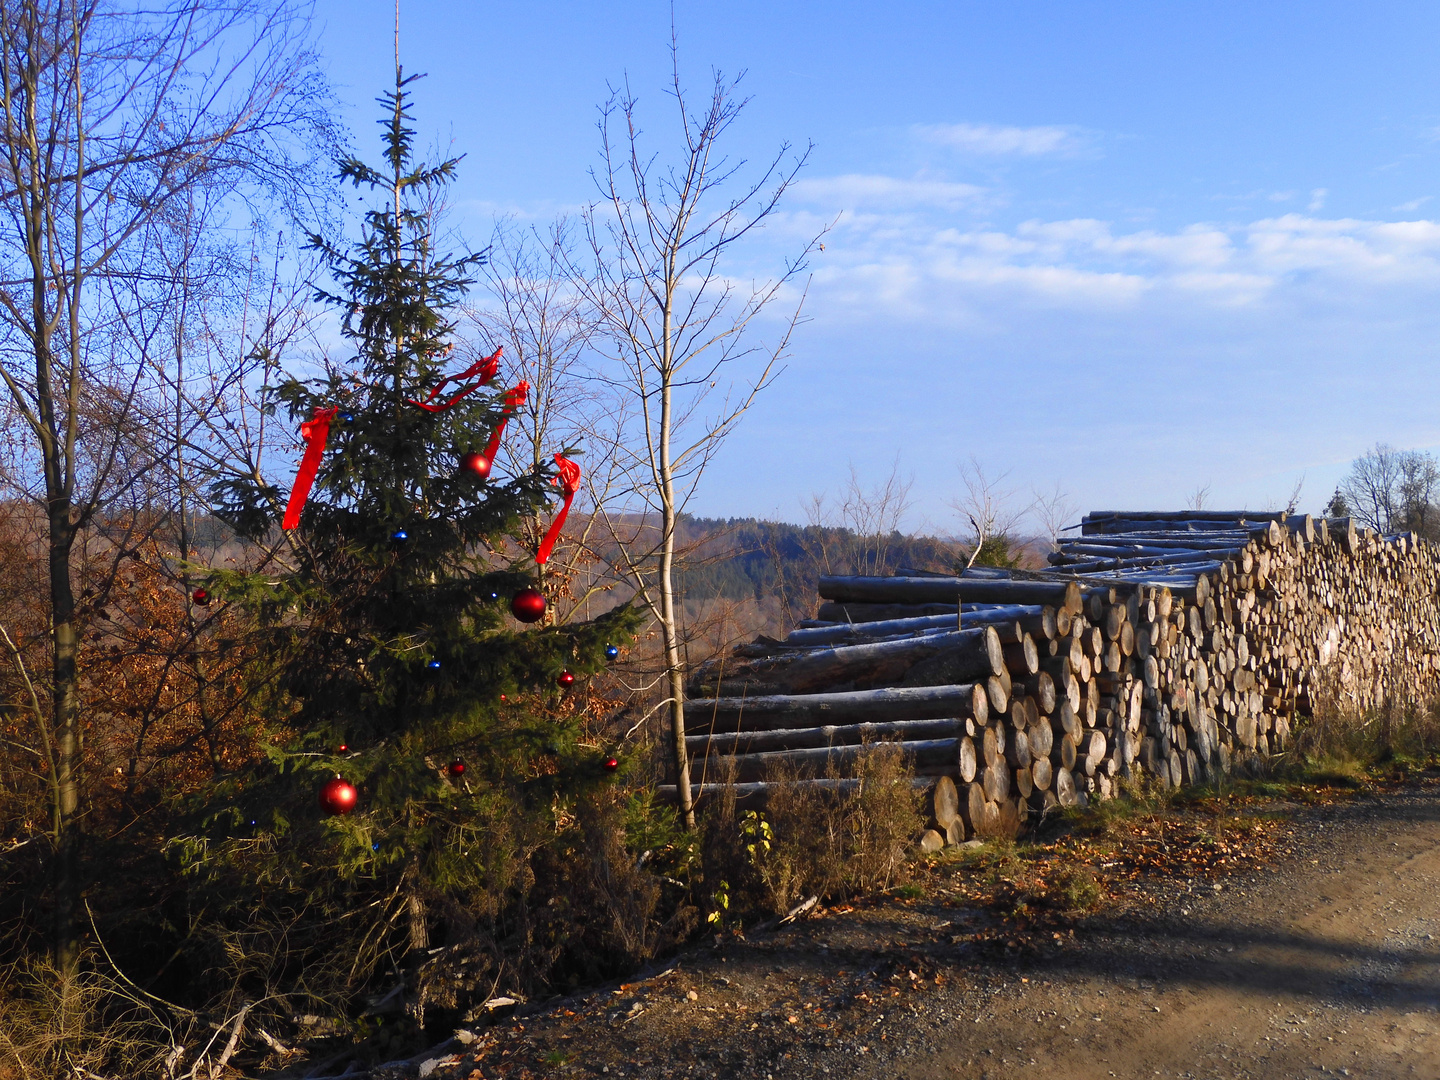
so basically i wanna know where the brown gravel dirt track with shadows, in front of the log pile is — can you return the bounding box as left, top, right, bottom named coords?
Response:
left=433, top=779, right=1440, bottom=1080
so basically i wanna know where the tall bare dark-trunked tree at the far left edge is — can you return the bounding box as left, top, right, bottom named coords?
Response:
left=0, top=0, right=328, bottom=976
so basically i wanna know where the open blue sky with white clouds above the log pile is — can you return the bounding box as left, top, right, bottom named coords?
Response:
left=309, top=0, right=1440, bottom=530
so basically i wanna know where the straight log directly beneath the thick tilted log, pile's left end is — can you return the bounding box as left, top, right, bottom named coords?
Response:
left=685, top=684, right=989, bottom=734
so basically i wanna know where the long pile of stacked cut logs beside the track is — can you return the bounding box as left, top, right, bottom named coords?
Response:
left=673, top=511, right=1440, bottom=842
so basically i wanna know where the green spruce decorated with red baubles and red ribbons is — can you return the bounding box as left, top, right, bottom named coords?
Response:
left=207, top=69, right=636, bottom=1025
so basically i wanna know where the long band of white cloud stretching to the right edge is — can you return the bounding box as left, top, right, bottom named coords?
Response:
left=794, top=192, right=1440, bottom=324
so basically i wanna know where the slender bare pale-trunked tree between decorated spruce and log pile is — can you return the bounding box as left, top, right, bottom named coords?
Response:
left=575, top=57, right=819, bottom=827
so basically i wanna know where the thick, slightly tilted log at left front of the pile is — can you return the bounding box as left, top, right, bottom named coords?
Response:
left=688, top=626, right=1005, bottom=697
